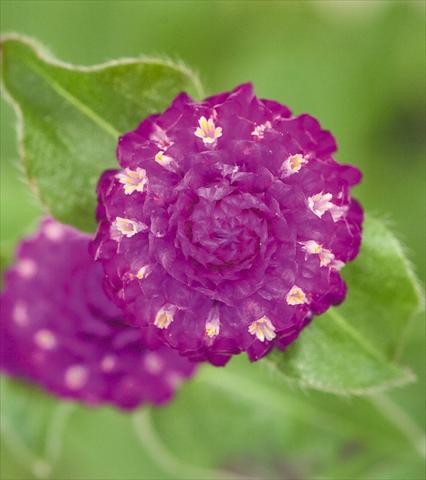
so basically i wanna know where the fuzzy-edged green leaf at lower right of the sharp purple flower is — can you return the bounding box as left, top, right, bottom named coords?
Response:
left=265, top=216, right=423, bottom=394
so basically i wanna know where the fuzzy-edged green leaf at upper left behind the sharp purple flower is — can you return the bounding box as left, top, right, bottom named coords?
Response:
left=1, top=35, right=201, bottom=231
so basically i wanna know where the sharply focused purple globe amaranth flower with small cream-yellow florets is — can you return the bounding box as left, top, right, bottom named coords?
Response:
left=92, top=84, right=362, bottom=365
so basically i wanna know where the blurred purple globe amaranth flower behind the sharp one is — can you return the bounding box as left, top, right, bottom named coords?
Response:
left=0, top=219, right=194, bottom=408
